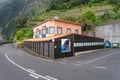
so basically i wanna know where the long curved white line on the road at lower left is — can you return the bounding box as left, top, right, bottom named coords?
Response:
left=5, top=53, right=58, bottom=80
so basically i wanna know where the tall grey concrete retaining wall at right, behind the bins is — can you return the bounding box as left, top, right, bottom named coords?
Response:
left=88, top=24, right=120, bottom=43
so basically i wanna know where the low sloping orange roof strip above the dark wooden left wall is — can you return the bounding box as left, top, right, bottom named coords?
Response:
left=25, top=34, right=71, bottom=42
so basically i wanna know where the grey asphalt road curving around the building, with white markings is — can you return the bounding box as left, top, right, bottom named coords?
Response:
left=0, top=44, right=120, bottom=80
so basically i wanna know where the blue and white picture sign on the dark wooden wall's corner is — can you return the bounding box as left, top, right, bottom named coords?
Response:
left=61, top=39, right=71, bottom=53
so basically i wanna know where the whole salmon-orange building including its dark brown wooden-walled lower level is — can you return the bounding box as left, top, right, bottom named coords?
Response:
left=24, top=19, right=104, bottom=58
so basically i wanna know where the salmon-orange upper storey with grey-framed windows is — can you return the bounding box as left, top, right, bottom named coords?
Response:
left=33, top=19, right=82, bottom=38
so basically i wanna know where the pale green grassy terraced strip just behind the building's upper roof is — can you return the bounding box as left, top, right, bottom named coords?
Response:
left=26, top=5, right=113, bottom=27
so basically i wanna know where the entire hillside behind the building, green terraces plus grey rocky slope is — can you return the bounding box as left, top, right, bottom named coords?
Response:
left=2, top=0, right=120, bottom=40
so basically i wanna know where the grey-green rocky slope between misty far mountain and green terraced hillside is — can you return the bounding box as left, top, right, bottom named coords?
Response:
left=2, top=0, right=53, bottom=40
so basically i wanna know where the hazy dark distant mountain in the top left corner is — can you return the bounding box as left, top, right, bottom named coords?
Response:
left=0, top=0, right=26, bottom=27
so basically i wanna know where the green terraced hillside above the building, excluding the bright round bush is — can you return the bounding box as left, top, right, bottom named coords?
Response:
left=25, top=0, right=120, bottom=27
